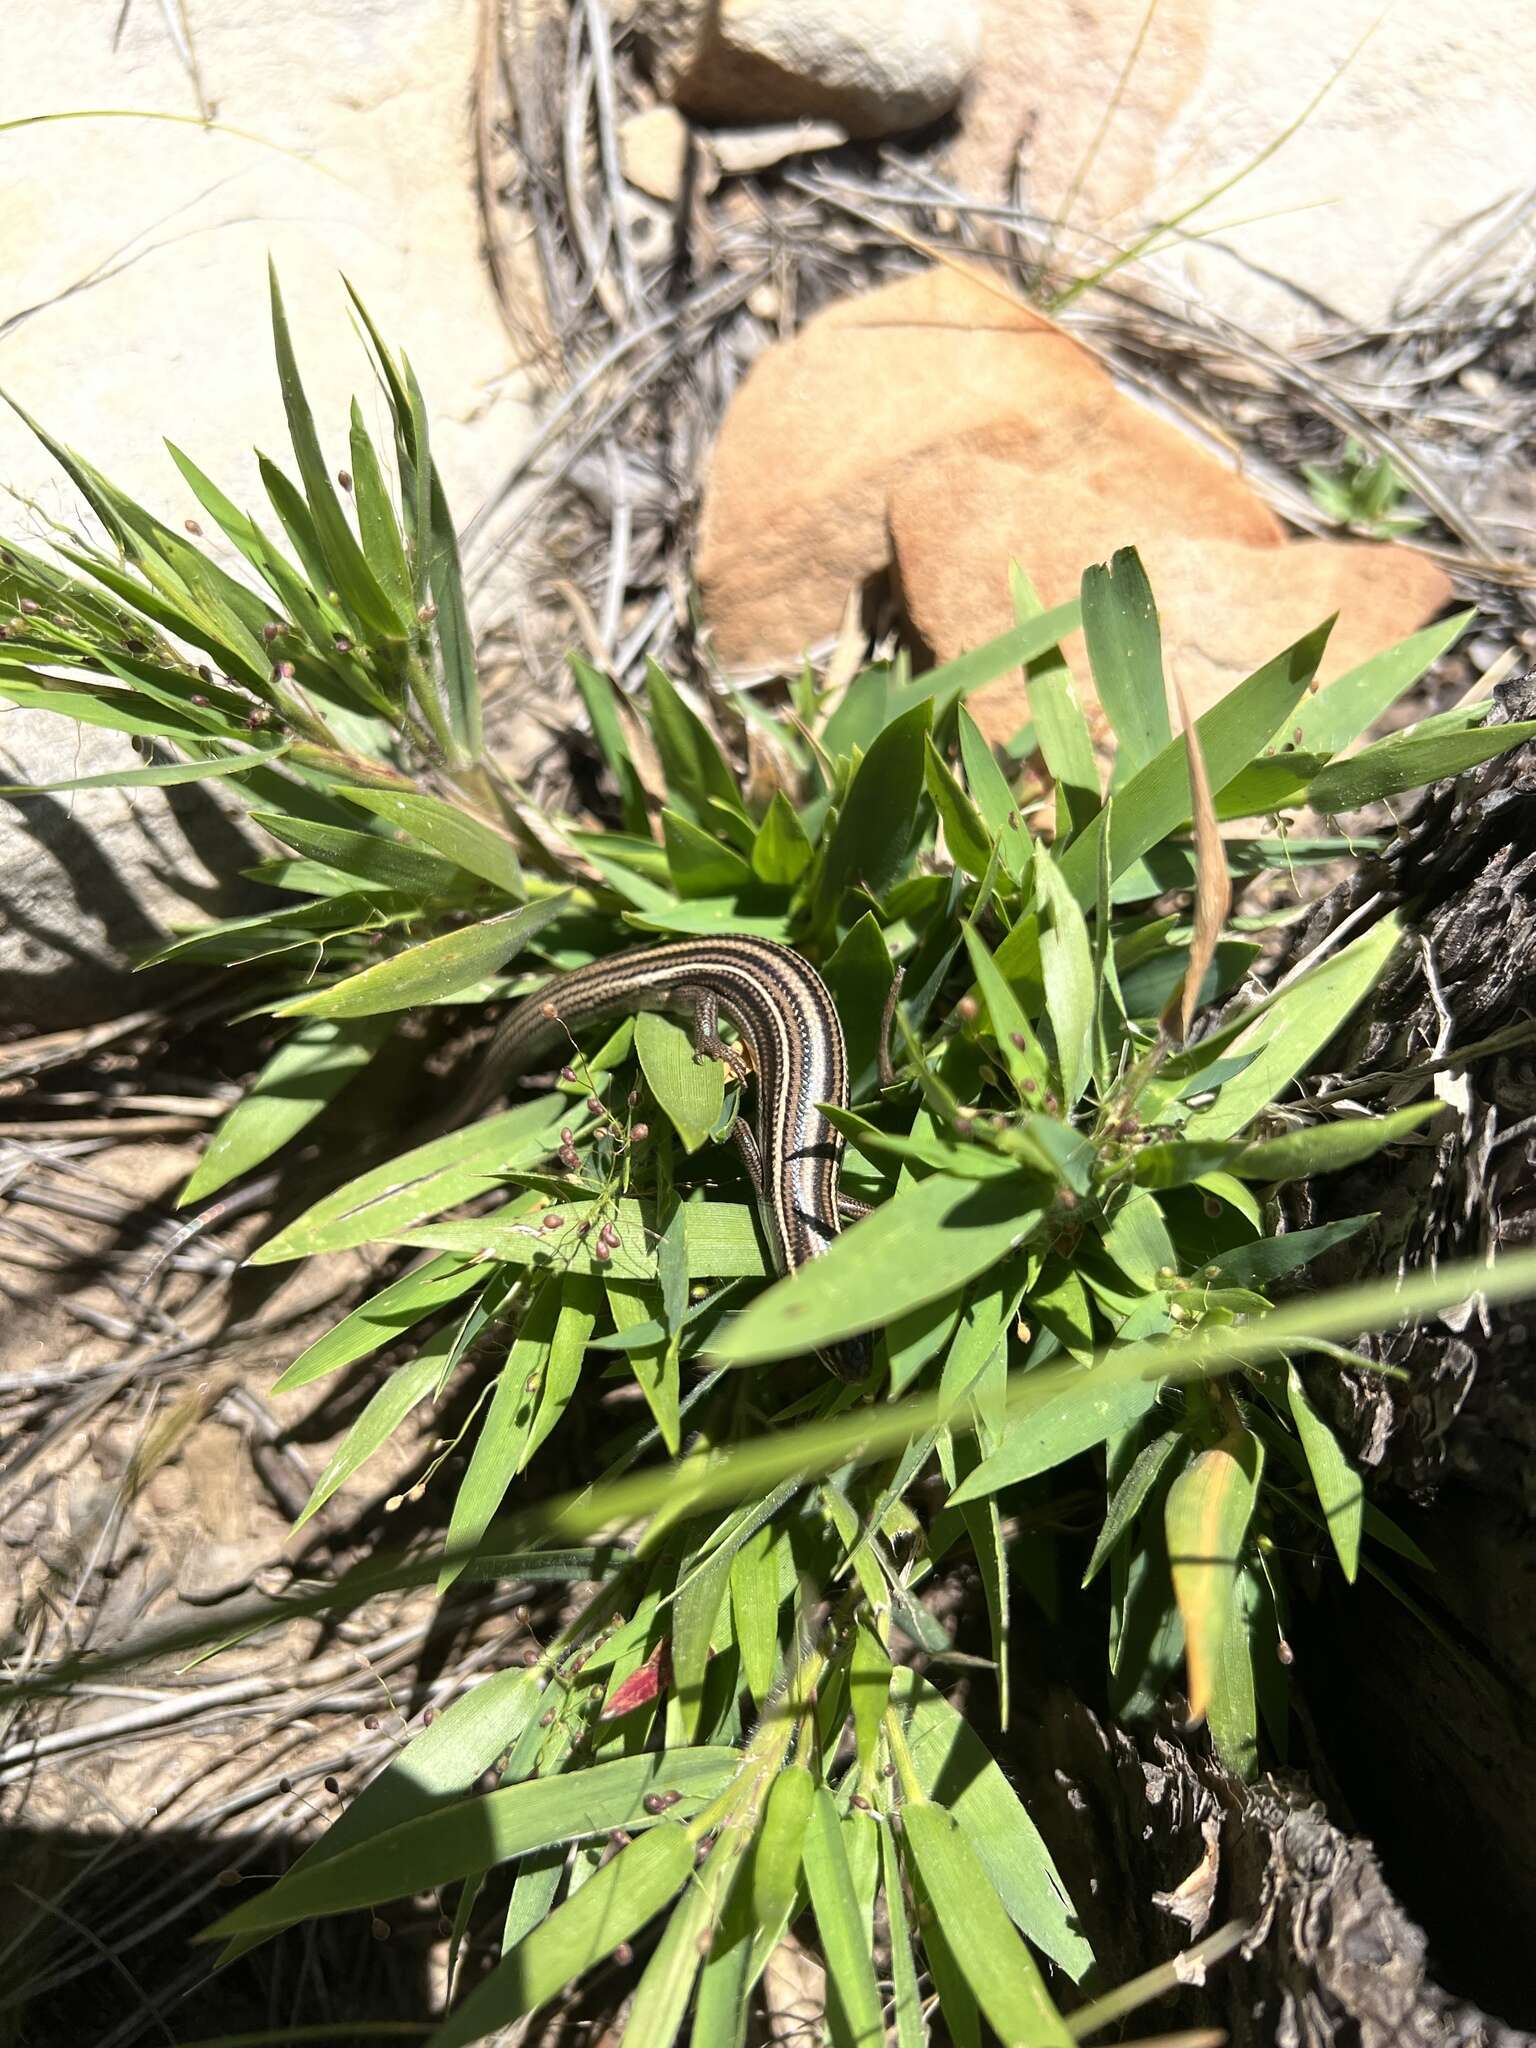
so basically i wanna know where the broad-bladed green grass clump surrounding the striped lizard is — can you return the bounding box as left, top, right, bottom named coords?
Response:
left=0, top=287, right=1536, bottom=2048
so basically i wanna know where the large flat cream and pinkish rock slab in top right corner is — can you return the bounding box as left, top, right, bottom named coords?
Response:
left=950, top=0, right=1536, bottom=346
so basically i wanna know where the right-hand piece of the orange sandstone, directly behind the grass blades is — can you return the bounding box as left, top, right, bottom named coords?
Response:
left=891, top=455, right=1450, bottom=743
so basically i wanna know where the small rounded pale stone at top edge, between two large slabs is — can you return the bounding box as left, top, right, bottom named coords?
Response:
left=633, top=0, right=981, bottom=135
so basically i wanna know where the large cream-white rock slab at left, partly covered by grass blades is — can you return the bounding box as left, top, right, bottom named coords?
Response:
left=0, top=0, right=530, bottom=1026
